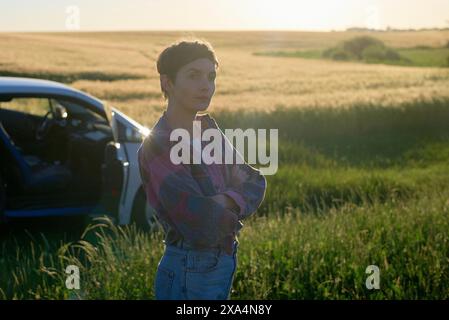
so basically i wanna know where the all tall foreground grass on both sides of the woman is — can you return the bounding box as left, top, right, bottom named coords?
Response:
left=0, top=192, right=449, bottom=299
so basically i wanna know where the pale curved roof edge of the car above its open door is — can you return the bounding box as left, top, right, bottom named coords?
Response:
left=0, top=77, right=105, bottom=114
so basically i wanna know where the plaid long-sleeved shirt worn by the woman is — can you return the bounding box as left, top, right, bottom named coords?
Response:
left=138, top=112, right=266, bottom=253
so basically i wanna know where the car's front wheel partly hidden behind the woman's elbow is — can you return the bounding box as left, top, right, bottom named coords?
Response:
left=132, top=189, right=161, bottom=232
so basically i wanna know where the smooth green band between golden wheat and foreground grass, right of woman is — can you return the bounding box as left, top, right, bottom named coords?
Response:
left=215, top=100, right=449, bottom=213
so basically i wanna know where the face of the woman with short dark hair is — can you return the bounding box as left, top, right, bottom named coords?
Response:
left=168, top=58, right=216, bottom=112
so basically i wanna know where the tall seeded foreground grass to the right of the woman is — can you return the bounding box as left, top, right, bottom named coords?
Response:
left=233, top=189, right=449, bottom=299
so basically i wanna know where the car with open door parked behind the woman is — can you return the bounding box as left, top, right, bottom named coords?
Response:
left=0, top=77, right=158, bottom=231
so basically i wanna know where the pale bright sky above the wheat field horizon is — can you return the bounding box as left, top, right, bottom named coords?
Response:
left=0, top=0, right=449, bottom=32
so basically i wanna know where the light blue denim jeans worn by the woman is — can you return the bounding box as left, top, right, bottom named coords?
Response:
left=155, top=241, right=238, bottom=300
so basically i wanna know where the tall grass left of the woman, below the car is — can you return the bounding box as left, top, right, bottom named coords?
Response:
left=0, top=218, right=162, bottom=299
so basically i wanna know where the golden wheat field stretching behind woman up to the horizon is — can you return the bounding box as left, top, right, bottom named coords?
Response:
left=0, top=31, right=449, bottom=126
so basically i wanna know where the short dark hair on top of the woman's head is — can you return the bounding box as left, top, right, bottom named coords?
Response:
left=157, top=39, right=218, bottom=98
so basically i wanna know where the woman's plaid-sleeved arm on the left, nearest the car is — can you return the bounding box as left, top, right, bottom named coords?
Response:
left=139, top=137, right=242, bottom=247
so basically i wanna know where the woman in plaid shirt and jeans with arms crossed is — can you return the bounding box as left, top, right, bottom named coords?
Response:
left=138, top=40, right=266, bottom=300
